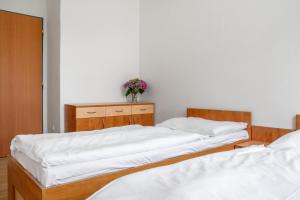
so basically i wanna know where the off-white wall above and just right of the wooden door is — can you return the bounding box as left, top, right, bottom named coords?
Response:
left=0, top=0, right=48, bottom=131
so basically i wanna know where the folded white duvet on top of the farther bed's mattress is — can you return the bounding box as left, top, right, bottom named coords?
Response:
left=11, top=125, right=208, bottom=167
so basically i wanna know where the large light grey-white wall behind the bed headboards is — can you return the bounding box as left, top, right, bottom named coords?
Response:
left=140, top=0, right=300, bottom=128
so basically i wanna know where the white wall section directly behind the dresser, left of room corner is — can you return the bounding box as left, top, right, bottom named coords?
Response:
left=60, top=0, right=139, bottom=130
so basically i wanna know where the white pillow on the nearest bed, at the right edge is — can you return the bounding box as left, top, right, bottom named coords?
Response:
left=268, top=130, right=300, bottom=149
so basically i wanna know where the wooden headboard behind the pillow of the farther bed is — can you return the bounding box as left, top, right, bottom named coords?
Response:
left=187, top=108, right=252, bottom=135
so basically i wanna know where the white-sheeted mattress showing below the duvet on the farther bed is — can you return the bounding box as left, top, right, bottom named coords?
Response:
left=13, top=131, right=249, bottom=187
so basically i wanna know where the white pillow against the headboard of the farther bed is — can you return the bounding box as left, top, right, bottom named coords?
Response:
left=157, top=117, right=247, bottom=136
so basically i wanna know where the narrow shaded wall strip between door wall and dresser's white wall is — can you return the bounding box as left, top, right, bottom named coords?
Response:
left=47, top=0, right=60, bottom=132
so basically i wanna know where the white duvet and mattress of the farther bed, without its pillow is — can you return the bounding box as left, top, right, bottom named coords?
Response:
left=11, top=117, right=249, bottom=187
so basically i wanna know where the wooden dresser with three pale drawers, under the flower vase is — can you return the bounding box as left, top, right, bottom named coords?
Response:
left=65, top=102, right=154, bottom=132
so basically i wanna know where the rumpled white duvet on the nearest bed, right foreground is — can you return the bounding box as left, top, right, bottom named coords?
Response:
left=89, top=146, right=300, bottom=200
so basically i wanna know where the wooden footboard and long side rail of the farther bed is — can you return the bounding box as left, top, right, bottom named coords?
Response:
left=8, top=141, right=244, bottom=200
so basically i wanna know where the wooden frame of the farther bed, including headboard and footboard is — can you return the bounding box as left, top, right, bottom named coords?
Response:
left=8, top=108, right=251, bottom=200
